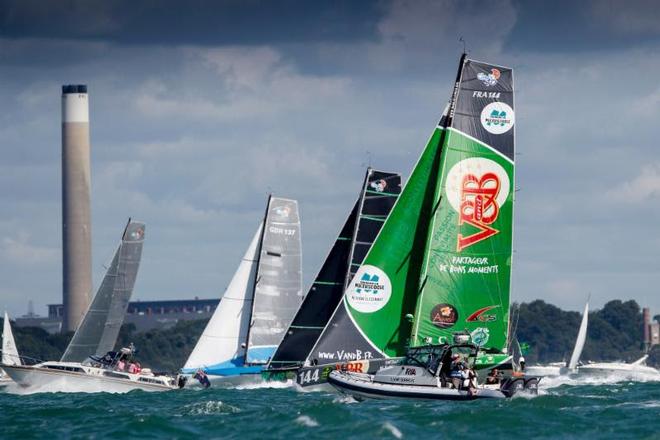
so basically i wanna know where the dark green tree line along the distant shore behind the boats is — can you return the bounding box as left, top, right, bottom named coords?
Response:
left=0, top=300, right=660, bottom=372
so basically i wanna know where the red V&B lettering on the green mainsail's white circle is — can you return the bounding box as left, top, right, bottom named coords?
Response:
left=456, top=172, right=500, bottom=252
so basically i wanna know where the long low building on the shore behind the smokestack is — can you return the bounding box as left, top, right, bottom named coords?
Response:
left=16, top=298, right=220, bottom=333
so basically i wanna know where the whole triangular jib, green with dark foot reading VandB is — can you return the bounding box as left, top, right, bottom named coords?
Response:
left=306, top=112, right=444, bottom=365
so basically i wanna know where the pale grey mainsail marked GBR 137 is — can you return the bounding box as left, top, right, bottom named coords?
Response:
left=245, top=196, right=303, bottom=365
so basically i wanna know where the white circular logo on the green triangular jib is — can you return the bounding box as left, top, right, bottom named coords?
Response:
left=346, top=264, right=392, bottom=313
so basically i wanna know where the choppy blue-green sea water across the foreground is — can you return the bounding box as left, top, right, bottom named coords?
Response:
left=0, top=377, right=660, bottom=440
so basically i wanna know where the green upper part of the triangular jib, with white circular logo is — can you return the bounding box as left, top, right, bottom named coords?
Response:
left=344, top=122, right=445, bottom=357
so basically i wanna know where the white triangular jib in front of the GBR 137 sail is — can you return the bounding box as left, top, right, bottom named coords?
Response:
left=183, top=223, right=263, bottom=373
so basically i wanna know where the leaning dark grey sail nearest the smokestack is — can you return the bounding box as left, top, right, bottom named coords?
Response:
left=61, top=220, right=145, bottom=362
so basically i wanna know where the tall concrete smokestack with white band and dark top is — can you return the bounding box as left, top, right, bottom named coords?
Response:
left=62, top=85, right=92, bottom=332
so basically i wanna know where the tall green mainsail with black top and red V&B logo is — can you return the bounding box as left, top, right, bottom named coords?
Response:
left=411, top=60, right=514, bottom=352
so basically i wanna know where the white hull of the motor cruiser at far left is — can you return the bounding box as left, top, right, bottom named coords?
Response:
left=3, top=365, right=176, bottom=393
